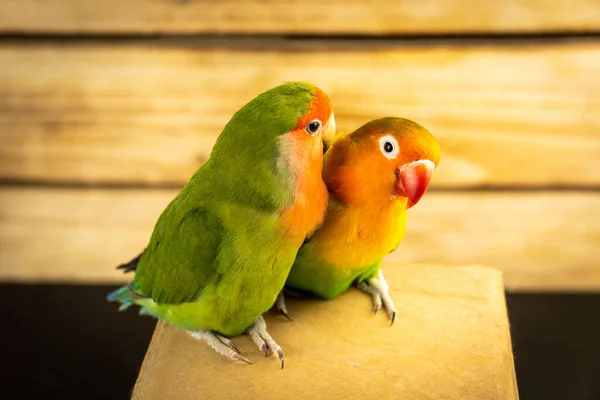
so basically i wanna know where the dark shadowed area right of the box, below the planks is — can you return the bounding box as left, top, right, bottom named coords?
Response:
left=506, top=293, right=600, bottom=400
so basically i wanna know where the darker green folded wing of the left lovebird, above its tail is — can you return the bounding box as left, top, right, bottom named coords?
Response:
left=133, top=202, right=224, bottom=304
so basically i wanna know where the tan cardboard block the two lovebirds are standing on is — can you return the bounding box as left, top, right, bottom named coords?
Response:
left=133, top=265, right=518, bottom=400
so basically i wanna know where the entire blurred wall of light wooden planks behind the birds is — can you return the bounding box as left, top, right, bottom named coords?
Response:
left=0, top=0, right=600, bottom=290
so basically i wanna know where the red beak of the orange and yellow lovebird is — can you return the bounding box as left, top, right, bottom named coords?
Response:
left=394, top=160, right=435, bottom=209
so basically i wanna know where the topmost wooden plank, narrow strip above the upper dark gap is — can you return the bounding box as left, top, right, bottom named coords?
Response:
left=0, top=0, right=600, bottom=35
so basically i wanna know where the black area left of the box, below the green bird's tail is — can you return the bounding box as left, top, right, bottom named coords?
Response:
left=0, top=284, right=156, bottom=400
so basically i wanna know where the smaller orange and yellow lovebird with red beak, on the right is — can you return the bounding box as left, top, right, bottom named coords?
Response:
left=276, top=118, right=440, bottom=323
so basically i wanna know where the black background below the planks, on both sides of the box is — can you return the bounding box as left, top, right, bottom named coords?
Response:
left=0, top=284, right=600, bottom=400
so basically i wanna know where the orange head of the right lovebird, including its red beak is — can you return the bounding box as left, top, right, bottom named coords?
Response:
left=323, top=118, right=440, bottom=208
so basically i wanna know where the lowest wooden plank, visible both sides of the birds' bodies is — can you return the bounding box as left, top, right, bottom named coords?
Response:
left=0, top=188, right=600, bottom=290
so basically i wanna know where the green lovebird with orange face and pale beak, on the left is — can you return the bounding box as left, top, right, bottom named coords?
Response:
left=107, top=82, right=335, bottom=368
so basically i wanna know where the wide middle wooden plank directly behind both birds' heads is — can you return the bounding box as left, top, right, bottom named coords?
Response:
left=0, top=39, right=600, bottom=188
